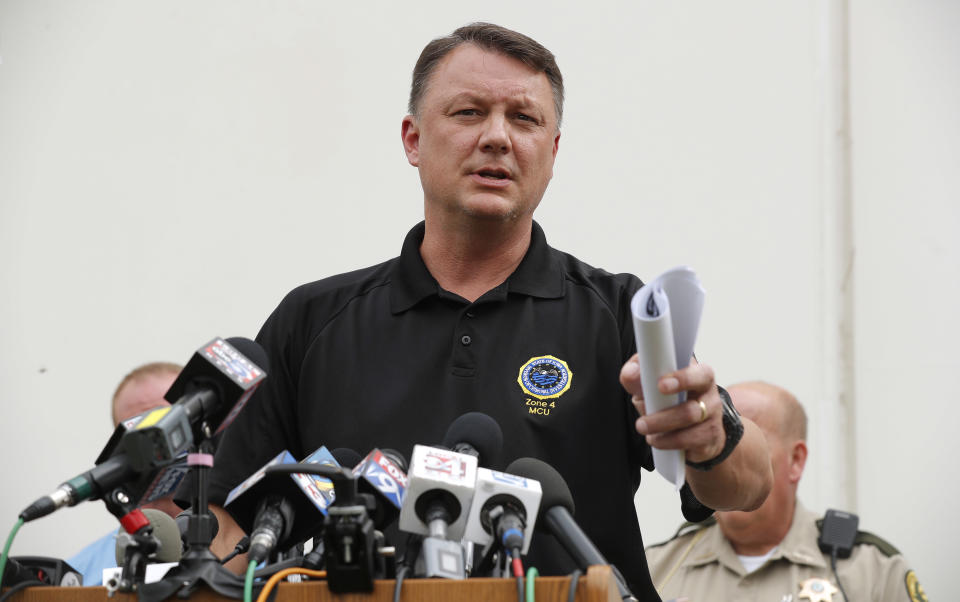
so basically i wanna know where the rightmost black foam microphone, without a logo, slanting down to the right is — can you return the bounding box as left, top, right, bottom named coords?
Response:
left=507, top=458, right=636, bottom=600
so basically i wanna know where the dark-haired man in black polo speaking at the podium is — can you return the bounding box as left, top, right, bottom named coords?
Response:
left=204, top=24, right=771, bottom=599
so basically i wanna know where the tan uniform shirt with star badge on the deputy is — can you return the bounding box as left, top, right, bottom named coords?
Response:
left=647, top=503, right=926, bottom=602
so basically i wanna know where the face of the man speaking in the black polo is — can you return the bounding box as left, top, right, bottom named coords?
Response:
left=402, top=44, right=560, bottom=221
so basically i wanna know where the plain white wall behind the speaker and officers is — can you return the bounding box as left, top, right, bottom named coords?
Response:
left=0, top=0, right=960, bottom=599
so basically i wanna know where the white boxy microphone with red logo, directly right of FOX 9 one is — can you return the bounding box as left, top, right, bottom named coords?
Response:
left=400, top=445, right=477, bottom=579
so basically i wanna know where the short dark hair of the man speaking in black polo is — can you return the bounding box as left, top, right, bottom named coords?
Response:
left=407, top=23, right=563, bottom=127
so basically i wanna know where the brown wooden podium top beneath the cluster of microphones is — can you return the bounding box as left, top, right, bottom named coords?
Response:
left=3, top=566, right=620, bottom=602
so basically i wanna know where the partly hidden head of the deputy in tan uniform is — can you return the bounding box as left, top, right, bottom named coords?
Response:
left=717, top=381, right=807, bottom=553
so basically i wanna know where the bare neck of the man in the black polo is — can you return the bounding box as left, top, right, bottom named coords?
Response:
left=420, top=217, right=533, bottom=302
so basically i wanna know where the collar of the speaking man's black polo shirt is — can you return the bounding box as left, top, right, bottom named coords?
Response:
left=390, top=222, right=564, bottom=314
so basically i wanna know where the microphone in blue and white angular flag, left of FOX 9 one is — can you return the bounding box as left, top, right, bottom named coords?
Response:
left=224, top=446, right=340, bottom=560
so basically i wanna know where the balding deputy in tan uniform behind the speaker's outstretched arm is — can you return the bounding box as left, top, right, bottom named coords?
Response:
left=647, top=382, right=927, bottom=602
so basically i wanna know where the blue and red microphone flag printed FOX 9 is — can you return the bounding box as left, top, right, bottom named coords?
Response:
left=353, top=449, right=409, bottom=531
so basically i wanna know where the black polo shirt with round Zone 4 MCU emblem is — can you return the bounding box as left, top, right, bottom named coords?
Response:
left=211, top=223, right=704, bottom=600
